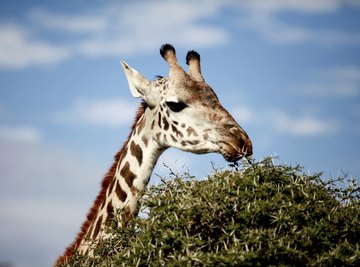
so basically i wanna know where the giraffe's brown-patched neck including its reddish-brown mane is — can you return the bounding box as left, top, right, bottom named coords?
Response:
left=55, top=103, right=165, bottom=266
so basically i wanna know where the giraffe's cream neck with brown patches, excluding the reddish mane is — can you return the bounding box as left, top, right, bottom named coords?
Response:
left=78, top=109, right=164, bottom=254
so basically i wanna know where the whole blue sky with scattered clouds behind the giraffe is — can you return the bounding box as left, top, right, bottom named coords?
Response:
left=0, top=0, right=360, bottom=266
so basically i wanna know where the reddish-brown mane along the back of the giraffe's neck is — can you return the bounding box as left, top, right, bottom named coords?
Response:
left=55, top=101, right=147, bottom=266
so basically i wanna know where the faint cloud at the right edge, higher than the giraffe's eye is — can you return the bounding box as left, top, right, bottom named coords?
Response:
left=295, top=66, right=360, bottom=98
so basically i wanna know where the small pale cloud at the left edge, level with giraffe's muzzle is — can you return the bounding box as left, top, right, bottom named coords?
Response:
left=0, top=125, right=42, bottom=143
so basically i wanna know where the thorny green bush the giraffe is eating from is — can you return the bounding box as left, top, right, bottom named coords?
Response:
left=65, top=158, right=360, bottom=266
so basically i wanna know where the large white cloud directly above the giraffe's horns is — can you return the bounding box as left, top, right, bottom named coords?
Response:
left=73, top=1, right=229, bottom=56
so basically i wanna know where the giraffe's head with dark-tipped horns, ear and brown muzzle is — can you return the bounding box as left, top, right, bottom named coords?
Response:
left=121, top=44, right=252, bottom=162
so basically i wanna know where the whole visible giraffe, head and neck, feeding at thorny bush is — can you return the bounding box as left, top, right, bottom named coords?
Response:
left=55, top=44, right=252, bottom=265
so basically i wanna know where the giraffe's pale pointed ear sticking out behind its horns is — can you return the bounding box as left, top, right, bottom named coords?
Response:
left=121, top=61, right=151, bottom=98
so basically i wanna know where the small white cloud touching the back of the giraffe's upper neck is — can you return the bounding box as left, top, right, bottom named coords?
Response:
left=53, top=99, right=137, bottom=127
